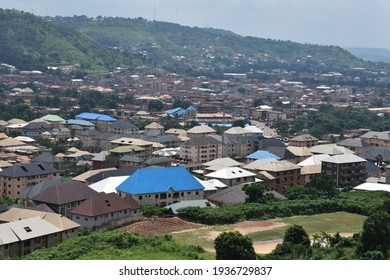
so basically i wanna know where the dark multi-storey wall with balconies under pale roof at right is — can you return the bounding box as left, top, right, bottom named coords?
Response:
left=321, top=161, right=367, bottom=188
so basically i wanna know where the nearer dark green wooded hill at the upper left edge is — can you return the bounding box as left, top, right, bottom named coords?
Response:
left=0, top=9, right=133, bottom=71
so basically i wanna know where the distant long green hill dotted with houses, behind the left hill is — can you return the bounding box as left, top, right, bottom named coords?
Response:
left=44, top=16, right=367, bottom=76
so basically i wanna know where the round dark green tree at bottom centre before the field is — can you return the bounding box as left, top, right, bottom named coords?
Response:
left=214, top=231, right=257, bottom=260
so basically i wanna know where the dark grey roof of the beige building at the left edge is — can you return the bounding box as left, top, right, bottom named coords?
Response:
left=0, top=162, right=58, bottom=178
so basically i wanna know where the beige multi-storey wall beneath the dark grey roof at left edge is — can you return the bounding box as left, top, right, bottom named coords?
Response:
left=0, top=173, right=59, bottom=197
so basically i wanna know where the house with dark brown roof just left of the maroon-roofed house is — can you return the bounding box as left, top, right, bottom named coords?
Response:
left=31, top=181, right=96, bottom=219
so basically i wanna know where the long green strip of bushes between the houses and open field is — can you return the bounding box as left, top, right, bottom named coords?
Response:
left=178, top=192, right=390, bottom=225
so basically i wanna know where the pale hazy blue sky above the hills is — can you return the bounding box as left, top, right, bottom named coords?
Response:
left=0, top=0, right=390, bottom=49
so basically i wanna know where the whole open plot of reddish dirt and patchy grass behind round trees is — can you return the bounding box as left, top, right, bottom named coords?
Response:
left=121, top=212, right=366, bottom=258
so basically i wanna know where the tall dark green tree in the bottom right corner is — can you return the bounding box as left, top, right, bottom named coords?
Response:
left=361, top=211, right=390, bottom=259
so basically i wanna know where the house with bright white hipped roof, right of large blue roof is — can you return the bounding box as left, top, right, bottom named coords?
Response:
left=205, top=167, right=256, bottom=186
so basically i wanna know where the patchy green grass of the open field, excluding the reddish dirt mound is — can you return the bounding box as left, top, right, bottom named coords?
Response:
left=172, top=212, right=366, bottom=259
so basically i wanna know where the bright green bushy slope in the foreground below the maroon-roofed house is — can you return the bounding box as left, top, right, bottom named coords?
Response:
left=22, top=231, right=204, bottom=260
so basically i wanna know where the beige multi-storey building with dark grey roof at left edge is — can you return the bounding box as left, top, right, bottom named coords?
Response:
left=0, top=163, right=59, bottom=197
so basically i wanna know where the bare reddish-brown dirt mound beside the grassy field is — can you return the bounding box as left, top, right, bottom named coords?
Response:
left=119, top=217, right=203, bottom=237
